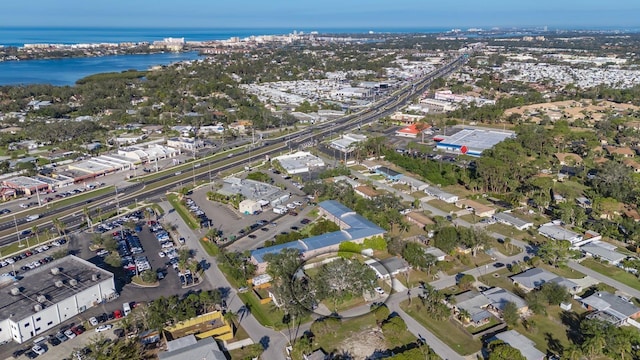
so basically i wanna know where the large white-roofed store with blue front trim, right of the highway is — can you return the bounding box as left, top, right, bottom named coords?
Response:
left=433, top=128, right=515, bottom=157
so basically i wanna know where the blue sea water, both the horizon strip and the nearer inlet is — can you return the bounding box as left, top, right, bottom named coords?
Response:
left=0, top=26, right=448, bottom=85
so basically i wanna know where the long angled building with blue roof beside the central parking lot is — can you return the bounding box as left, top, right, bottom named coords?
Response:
left=251, top=200, right=386, bottom=273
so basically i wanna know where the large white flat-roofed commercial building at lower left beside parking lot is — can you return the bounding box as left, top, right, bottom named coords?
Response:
left=0, top=255, right=117, bottom=344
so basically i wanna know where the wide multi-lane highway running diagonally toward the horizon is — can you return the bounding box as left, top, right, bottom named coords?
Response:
left=0, top=55, right=467, bottom=255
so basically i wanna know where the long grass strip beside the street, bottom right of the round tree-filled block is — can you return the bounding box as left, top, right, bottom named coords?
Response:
left=400, top=300, right=482, bottom=356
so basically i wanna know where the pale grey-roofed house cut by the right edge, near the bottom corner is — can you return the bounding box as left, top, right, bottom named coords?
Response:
left=580, top=291, right=640, bottom=327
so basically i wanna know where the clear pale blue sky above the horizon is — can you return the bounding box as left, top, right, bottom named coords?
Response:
left=0, top=0, right=640, bottom=31
